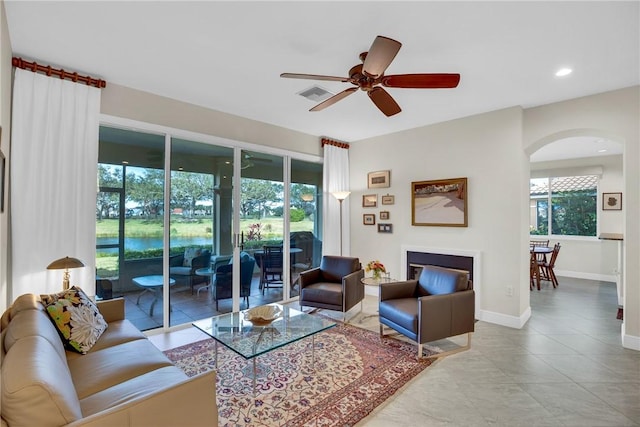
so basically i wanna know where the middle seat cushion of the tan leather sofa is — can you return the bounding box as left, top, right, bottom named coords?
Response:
left=67, top=339, right=173, bottom=399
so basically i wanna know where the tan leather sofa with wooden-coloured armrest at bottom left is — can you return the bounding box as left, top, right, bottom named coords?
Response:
left=0, top=294, right=218, bottom=427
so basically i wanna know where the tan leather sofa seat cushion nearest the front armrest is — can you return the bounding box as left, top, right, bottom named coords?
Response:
left=80, top=366, right=188, bottom=417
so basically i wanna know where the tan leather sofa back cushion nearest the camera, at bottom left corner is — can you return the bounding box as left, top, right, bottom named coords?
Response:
left=0, top=336, right=82, bottom=427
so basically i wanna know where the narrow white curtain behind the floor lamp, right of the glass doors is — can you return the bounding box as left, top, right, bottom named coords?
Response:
left=322, top=144, right=351, bottom=256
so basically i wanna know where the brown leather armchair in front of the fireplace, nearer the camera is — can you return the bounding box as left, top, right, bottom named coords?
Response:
left=379, top=265, right=475, bottom=358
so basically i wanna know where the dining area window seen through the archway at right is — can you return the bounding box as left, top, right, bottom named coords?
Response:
left=529, top=175, right=598, bottom=236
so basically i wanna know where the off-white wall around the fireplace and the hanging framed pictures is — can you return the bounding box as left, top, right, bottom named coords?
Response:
left=348, top=107, right=529, bottom=326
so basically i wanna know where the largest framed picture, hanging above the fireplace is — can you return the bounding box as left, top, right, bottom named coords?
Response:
left=411, top=177, right=468, bottom=227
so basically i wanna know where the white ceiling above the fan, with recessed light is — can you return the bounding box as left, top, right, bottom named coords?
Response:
left=5, top=0, right=640, bottom=160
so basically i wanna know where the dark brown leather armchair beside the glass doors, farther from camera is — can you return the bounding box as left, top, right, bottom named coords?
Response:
left=299, top=255, right=364, bottom=320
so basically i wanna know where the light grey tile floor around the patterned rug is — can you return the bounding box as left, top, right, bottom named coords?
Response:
left=150, top=277, right=640, bottom=427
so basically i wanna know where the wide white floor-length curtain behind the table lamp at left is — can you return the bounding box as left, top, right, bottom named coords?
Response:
left=9, top=69, right=100, bottom=300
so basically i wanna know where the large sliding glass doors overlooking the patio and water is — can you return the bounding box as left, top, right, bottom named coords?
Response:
left=96, top=125, right=322, bottom=330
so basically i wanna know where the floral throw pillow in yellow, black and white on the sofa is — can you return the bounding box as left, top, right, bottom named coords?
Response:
left=40, top=286, right=107, bottom=354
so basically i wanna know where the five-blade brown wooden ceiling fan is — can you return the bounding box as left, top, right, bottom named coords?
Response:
left=280, top=36, right=460, bottom=117
